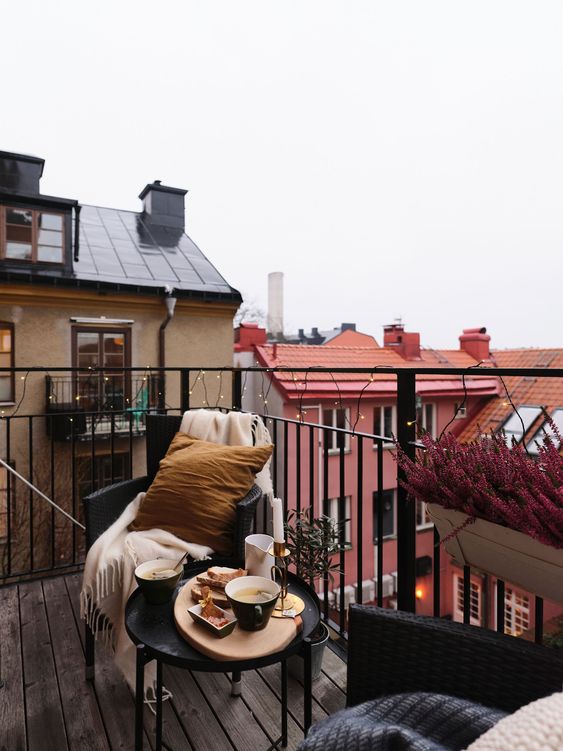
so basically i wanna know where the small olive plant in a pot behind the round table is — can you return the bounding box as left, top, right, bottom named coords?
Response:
left=285, top=507, right=347, bottom=680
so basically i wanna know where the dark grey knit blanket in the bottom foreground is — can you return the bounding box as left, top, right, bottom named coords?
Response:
left=299, top=693, right=506, bottom=751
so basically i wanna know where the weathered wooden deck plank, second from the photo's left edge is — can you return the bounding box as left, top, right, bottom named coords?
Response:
left=19, top=581, right=68, bottom=751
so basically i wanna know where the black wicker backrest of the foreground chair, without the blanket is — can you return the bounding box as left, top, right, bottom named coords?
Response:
left=347, top=605, right=563, bottom=712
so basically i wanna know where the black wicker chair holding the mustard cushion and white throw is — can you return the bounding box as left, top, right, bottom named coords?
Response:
left=83, top=415, right=262, bottom=680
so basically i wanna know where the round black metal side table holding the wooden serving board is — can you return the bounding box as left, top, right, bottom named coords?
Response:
left=125, top=563, right=321, bottom=751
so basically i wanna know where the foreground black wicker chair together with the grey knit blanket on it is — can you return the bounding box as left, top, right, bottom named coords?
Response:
left=300, top=605, right=563, bottom=751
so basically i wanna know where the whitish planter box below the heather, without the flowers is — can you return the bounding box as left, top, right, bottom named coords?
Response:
left=428, top=503, right=563, bottom=602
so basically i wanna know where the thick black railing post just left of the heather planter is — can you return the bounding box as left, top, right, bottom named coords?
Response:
left=397, top=371, right=416, bottom=613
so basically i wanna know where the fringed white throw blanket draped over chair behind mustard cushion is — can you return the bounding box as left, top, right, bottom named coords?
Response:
left=80, top=409, right=273, bottom=701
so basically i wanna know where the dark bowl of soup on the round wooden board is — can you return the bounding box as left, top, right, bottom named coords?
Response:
left=225, top=576, right=280, bottom=631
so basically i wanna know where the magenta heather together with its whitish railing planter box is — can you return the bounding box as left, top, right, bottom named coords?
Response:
left=397, top=423, right=563, bottom=602
